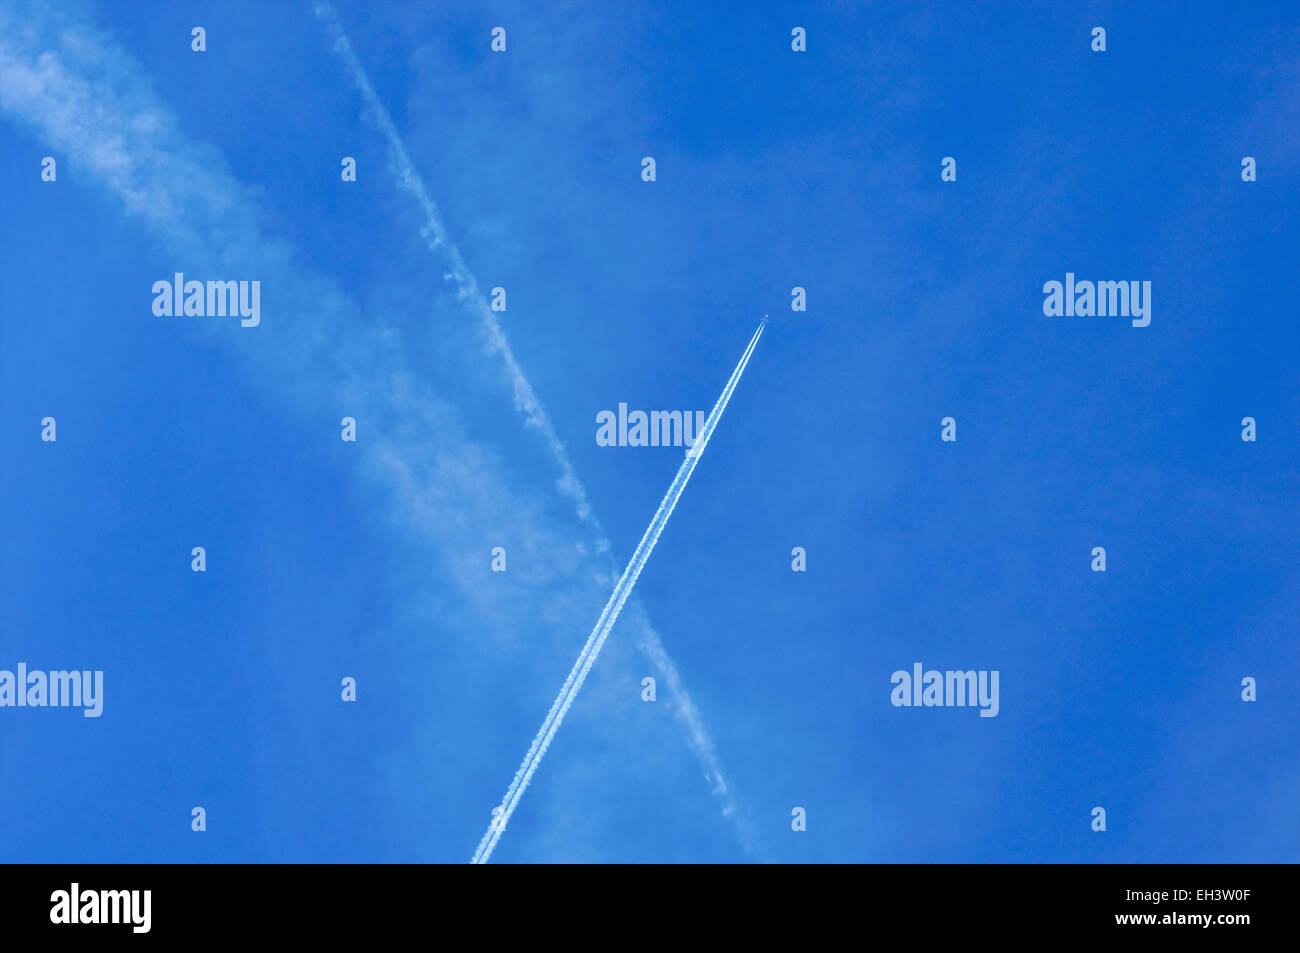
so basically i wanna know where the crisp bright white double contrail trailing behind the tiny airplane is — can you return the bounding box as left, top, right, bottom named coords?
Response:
left=471, top=321, right=767, bottom=863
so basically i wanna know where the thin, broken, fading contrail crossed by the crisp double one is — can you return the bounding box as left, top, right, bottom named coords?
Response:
left=315, top=0, right=767, bottom=859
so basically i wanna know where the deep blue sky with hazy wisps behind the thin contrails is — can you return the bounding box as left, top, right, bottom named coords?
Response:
left=0, top=3, right=1300, bottom=862
